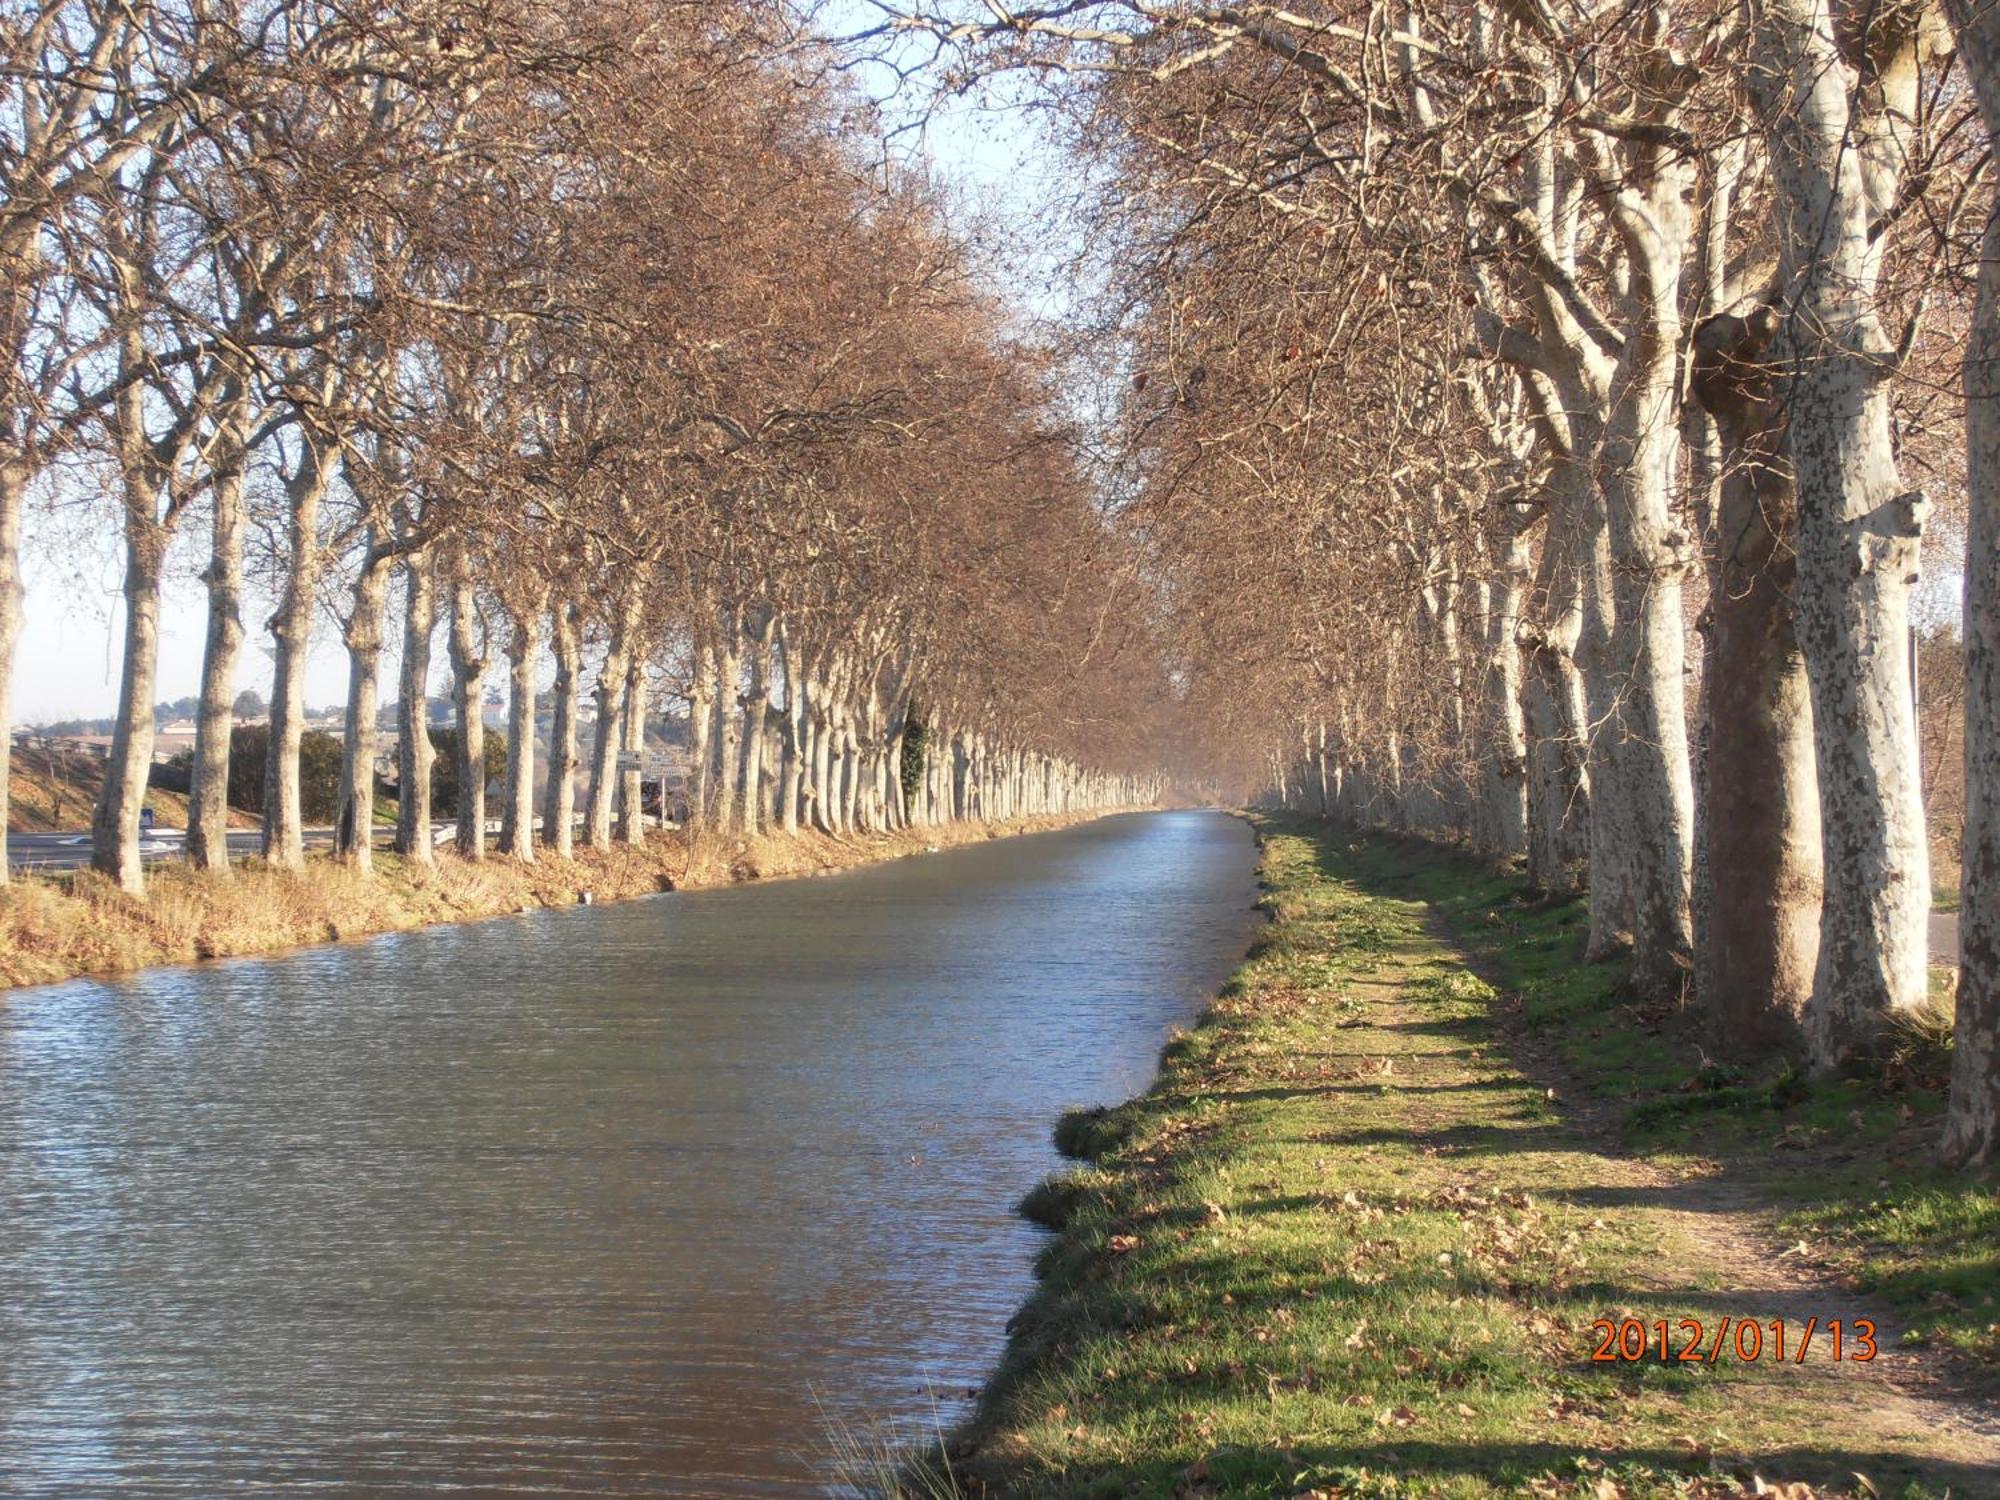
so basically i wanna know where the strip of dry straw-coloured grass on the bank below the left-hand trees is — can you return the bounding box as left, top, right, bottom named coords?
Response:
left=0, top=814, right=1102, bottom=986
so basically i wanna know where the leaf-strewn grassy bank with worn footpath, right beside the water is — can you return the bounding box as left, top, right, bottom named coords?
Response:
left=936, top=824, right=2000, bottom=1500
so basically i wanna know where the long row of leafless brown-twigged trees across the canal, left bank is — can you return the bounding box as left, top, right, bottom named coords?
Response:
left=0, top=0, right=1164, bottom=940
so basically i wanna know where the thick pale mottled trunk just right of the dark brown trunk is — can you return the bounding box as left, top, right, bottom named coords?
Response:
left=1750, top=0, right=1930, bottom=1072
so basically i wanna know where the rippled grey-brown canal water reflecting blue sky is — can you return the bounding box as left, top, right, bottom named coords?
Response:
left=0, top=812, right=1254, bottom=1496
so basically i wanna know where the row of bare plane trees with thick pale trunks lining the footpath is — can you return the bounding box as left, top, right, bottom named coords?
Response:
left=854, top=0, right=2000, bottom=1166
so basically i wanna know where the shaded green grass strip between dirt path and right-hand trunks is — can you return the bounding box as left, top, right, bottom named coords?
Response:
left=1352, top=840, right=2000, bottom=1366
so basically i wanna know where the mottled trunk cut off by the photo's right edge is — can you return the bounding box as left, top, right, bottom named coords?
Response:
left=1940, top=0, right=2000, bottom=1166
